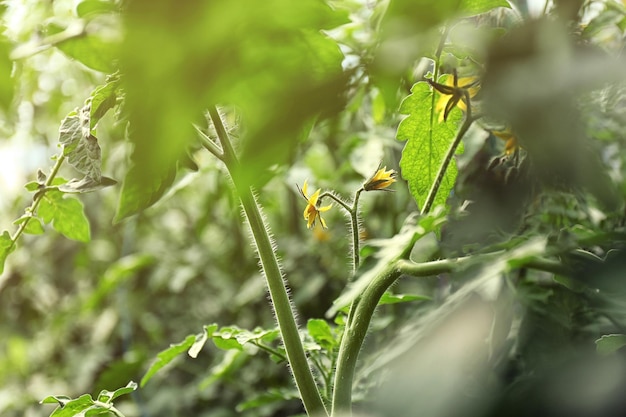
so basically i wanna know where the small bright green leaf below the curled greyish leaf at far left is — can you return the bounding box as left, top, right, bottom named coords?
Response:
left=37, top=190, right=91, bottom=242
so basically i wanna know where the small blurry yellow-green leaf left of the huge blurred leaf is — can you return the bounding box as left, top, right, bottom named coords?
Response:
left=47, top=23, right=118, bottom=74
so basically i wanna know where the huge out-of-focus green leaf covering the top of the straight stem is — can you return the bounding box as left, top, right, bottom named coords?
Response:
left=118, top=0, right=346, bottom=218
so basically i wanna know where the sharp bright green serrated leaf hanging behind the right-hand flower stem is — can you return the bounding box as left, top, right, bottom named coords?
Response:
left=396, top=82, right=463, bottom=211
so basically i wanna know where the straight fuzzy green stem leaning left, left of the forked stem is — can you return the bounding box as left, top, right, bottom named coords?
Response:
left=209, top=107, right=328, bottom=416
